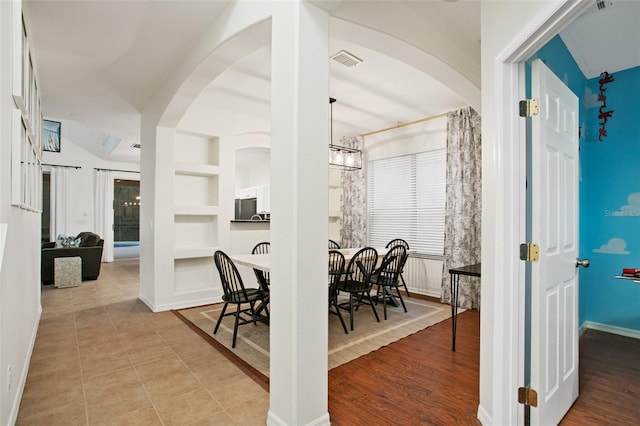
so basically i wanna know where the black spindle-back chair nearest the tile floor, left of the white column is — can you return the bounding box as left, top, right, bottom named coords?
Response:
left=213, top=250, right=269, bottom=348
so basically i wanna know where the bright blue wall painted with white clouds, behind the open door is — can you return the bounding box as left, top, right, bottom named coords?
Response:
left=536, top=36, right=640, bottom=331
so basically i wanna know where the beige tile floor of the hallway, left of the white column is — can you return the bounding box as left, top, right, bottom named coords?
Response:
left=17, top=259, right=269, bottom=425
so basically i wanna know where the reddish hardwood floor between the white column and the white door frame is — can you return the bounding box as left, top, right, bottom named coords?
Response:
left=329, top=311, right=480, bottom=426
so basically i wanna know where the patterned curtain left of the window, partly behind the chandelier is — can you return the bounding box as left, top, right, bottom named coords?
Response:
left=340, top=136, right=367, bottom=247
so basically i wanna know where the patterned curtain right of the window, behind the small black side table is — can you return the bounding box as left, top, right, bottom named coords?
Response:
left=441, top=107, right=482, bottom=309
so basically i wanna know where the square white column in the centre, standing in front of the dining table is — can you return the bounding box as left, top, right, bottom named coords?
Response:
left=267, top=0, right=329, bottom=425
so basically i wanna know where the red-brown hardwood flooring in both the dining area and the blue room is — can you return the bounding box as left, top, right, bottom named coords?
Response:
left=329, top=311, right=640, bottom=426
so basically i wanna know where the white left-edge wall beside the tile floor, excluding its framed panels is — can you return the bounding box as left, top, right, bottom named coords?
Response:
left=0, top=1, right=41, bottom=425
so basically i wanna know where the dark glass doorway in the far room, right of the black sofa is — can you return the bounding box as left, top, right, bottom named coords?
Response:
left=113, top=179, right=140, bottom=260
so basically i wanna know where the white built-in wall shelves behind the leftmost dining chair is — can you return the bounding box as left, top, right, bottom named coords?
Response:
left=173, top=131, right=220, bottom=293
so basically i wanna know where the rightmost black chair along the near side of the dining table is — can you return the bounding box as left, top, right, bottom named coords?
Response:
left=371, top=245, right=407, bottom=320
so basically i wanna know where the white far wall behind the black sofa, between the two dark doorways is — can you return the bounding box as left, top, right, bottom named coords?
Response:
left=42, top=118, right=140, bottom=240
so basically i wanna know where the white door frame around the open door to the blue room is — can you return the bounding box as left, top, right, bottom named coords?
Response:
left=490, top=0, right=592, bottom=424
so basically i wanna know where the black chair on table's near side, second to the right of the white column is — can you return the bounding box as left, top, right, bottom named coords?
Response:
left=338, top=247, right=380, bottom=330
